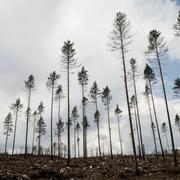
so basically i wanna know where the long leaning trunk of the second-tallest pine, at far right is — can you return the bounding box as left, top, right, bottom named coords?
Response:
left=155, top=44, right=177, bottom=166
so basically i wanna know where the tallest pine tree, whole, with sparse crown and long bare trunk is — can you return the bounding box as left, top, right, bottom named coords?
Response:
left=111, top=12, right=139, bottom=174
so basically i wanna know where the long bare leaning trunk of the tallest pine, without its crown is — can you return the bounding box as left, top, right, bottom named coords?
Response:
left=120, top=30, right=139, bottom=174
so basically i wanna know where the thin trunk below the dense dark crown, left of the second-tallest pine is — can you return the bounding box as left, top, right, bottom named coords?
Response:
left=149, top=79, right=164, bottom=159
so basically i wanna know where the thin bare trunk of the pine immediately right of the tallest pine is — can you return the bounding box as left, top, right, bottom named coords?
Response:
left=133, top=72, right=145, bottom=159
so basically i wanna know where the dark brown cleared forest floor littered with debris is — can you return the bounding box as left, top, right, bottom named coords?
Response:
left=0, top=155, right=180, bottom=180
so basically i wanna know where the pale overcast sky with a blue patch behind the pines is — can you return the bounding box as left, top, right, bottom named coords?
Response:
left=0, top=0, right=180, bottom=155
